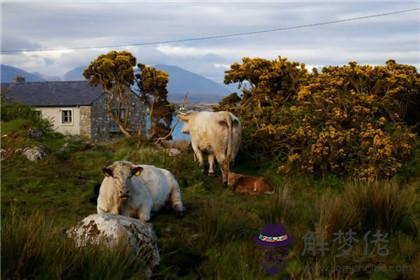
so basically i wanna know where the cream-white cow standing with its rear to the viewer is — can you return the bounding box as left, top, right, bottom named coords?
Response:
left=178, top=111, right=241, bottom=184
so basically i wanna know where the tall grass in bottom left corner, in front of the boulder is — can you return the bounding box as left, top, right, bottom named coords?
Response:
left=1, top=211, right=145, bottom=279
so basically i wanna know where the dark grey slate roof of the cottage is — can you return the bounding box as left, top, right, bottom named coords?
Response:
left=1, top=81, right=103, bottom=107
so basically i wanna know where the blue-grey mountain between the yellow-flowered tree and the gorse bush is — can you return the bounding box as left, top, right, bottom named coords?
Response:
left=155, top=64, right=230, bottom=103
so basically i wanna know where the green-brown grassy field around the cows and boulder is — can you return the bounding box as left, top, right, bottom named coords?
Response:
left=1, top=120, right=420, bottom=279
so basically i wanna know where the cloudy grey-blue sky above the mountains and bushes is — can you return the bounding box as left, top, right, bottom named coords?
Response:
left=1, top=0, right=420, bottom=82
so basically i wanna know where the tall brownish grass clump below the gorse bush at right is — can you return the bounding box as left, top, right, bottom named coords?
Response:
left=319, top=181, right=419, bottom=236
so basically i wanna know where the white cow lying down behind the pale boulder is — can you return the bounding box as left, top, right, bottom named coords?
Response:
left=97, top=161, right=184, bottom=221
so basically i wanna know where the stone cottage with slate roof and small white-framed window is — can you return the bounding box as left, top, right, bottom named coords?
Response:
left=2, top=81, right=146, bottom=140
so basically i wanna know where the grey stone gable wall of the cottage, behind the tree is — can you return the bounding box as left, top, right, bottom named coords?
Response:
left=91, top=92, right=146, bottom=141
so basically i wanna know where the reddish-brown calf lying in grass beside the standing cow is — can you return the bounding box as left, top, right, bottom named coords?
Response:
left=228, top=172, right=274, bottom=195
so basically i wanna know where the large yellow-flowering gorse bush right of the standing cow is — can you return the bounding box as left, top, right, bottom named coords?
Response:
left=223, top=58, right=420, bottom=182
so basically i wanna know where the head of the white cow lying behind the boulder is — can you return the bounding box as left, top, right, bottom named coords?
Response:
left=102, top=161, right=143, bottom=199
